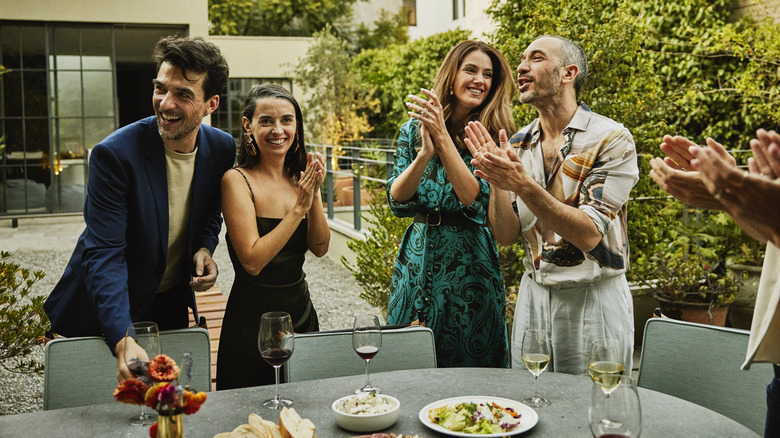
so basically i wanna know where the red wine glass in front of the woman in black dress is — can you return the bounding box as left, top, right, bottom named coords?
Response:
left=257, top=312, right=295, bottom=409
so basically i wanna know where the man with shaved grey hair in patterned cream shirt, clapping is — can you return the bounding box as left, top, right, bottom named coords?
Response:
left=467, top=36, right=639, bottom=374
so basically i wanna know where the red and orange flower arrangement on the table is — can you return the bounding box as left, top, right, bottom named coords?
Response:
left=114, top=353, right=207, bottom=437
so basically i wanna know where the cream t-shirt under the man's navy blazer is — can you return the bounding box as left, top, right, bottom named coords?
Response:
left=157, top=147, right=198, bottom=293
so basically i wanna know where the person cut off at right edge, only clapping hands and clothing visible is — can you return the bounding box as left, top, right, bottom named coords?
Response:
left=650, top=129, right=780, bottom=437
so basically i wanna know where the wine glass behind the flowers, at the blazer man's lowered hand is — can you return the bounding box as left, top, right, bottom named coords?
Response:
left=123, top=321, right=162, bottom=426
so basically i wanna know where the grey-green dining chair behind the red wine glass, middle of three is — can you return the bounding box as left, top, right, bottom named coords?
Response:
left=284, top=326, right=436, bottom=382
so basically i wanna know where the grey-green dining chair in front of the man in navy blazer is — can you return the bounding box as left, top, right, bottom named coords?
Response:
left=43, top=327, right=211, bottom=410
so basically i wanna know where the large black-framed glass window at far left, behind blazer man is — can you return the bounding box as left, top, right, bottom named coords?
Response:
left=0, top=20, right=181, bottom=216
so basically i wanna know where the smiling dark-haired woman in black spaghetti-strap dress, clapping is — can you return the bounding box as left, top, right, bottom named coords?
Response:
left=217, top=84, right=330, bottom=390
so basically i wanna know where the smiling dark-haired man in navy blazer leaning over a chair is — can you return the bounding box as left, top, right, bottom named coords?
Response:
left=44, top=36, right=235, bottom=380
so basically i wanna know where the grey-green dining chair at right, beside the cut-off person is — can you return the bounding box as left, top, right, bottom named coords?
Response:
left=637, top=318, right=774, bottom=435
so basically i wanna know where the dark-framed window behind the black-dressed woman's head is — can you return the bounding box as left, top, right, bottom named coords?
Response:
left=211, top=78, right=293, bottom=141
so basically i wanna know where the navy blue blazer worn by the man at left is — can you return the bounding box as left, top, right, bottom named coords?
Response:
left=44, top=116, right=236, bottom=349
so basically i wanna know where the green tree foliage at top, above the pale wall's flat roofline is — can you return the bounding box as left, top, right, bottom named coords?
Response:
left=209, top=0, right=356, bottom=36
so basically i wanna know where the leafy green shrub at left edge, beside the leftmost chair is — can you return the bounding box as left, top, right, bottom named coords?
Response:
left=0, top=251, right=49, bottom=373
